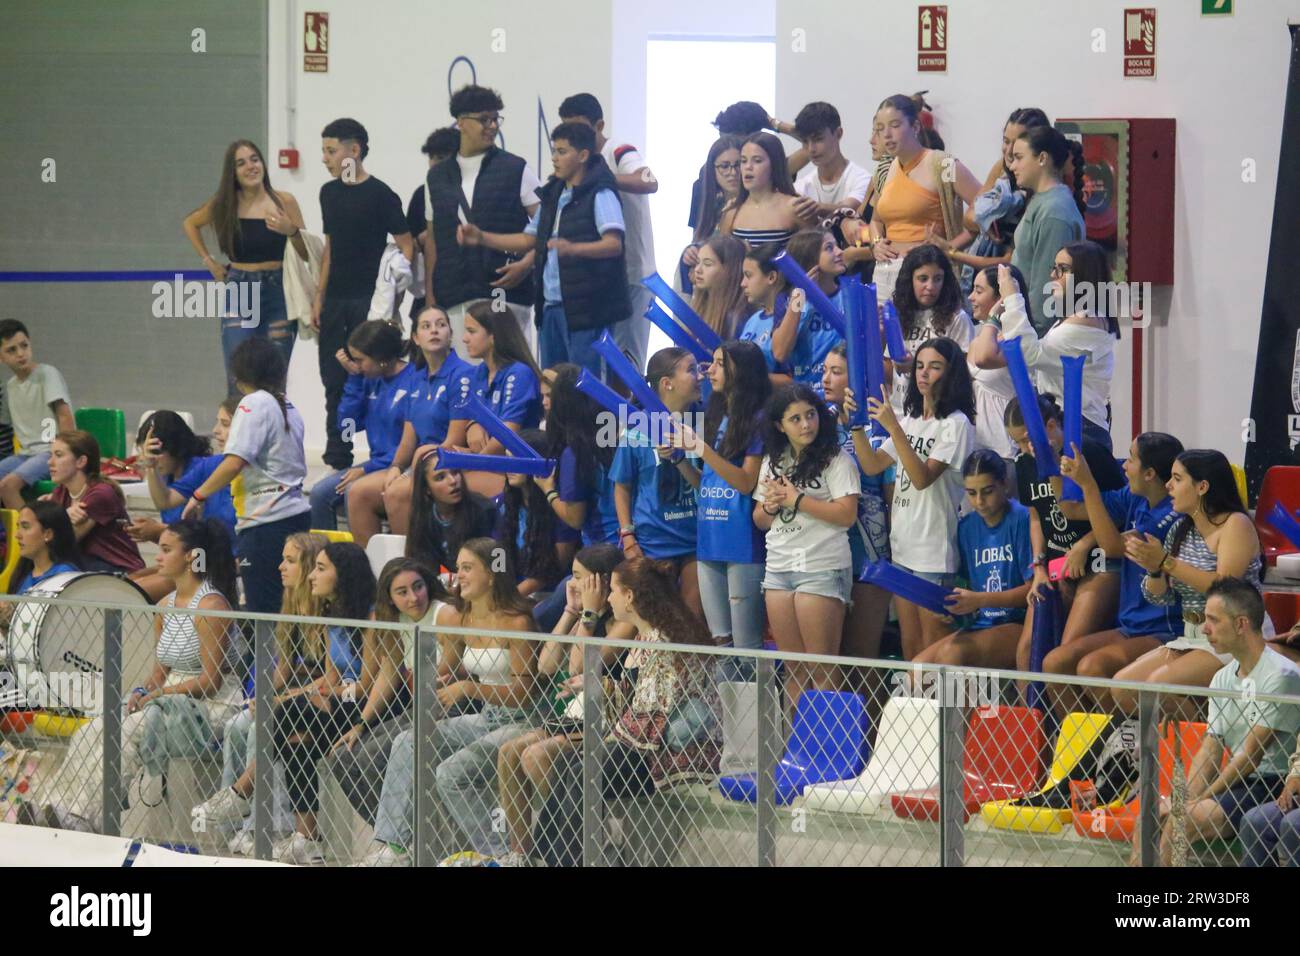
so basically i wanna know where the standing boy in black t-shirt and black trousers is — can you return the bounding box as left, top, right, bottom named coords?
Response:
left=312, top=120, right=415, bottom=470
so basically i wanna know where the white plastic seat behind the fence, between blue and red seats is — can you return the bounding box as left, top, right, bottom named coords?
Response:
left=803, top=697, right=939, bottom=813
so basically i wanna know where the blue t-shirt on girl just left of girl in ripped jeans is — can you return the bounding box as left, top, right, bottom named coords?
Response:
left=610, top=429, right=696, bottom=558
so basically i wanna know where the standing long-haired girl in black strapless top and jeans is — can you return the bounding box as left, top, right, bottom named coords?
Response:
left=182, top=139, right=307, bottom=392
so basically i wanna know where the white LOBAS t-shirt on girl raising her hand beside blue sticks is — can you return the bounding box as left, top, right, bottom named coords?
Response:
left=880, top=411, right=975, bottom=574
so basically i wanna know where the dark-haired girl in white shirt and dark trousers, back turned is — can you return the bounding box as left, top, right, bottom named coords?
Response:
left=183, top=338, right=311, bottom=614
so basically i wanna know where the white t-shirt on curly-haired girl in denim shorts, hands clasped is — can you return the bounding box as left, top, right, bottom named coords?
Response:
left=758, top=449, right=862, bottom=571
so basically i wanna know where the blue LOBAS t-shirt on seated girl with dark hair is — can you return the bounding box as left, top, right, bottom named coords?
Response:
left=957, top=501, right=1034, bottom=631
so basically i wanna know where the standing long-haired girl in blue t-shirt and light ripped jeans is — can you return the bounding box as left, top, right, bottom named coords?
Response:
left=672, top=342, right=772, bottom=676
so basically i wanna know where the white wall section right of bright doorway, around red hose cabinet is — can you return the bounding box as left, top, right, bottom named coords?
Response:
left=776, top=0, right=1300, bottom=462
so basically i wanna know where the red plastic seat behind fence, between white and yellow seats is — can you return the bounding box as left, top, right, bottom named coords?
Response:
left=889, top=706, right=1047, bottom=822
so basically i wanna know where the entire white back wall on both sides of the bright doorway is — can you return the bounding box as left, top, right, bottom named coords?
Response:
left=267, top=0, right=1300, bottom=460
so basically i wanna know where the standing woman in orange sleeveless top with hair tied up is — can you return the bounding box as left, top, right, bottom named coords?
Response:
left=871, top=94, right=980, bottom=302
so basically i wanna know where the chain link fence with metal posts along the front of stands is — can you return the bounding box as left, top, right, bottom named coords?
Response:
left=0, top=596, right=1300, bottom=866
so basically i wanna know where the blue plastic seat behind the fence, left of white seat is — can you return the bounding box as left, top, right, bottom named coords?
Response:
left=718, top=691, right=870, bottom=806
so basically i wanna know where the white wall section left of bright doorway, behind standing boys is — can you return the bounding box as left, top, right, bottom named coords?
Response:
left=264, top=0, right=611, bottom=449
